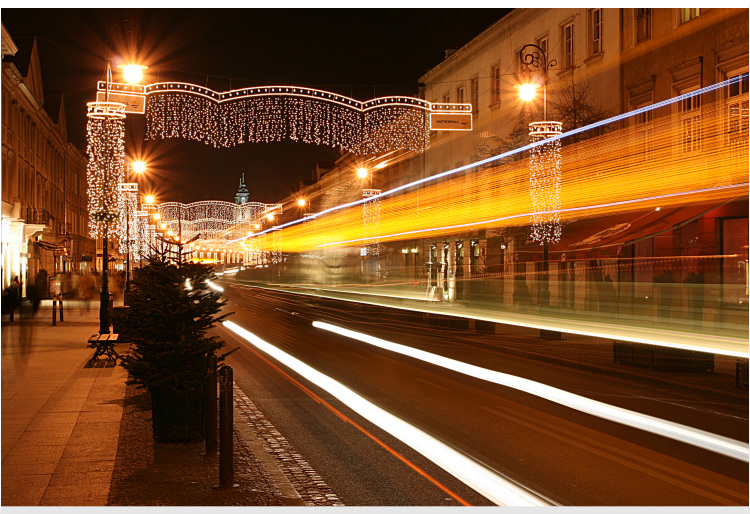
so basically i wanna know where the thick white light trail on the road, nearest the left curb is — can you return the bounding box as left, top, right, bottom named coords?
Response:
left=223, top=321, right=552, bottom=506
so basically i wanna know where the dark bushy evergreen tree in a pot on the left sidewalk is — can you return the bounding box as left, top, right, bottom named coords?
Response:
left=122, top=261, right=231, bottom=442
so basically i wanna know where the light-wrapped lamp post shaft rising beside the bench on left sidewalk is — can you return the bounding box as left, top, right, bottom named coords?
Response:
left=86, top=102, right=125, bottom=334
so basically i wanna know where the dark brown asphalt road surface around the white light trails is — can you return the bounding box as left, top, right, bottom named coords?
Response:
left=213, top=282, right=748, bottom=506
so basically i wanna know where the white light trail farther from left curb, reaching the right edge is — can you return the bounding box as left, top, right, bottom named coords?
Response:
left=313, top=321, right=750, bottom=462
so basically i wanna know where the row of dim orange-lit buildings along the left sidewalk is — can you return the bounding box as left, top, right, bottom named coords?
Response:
left=2, top=26, right=96, bottom=295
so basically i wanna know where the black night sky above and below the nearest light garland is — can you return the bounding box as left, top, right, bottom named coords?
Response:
left=2, top=8, right=509, bottom=203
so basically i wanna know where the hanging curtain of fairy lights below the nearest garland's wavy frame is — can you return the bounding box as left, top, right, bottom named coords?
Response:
left=146, top=90, right=429, bottom=154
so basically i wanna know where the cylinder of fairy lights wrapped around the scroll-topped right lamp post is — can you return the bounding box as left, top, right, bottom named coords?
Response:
left=529, top=121, right=562, bottom=243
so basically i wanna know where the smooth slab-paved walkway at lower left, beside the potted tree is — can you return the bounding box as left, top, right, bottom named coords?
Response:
left=2, top=300, right=127, bottom=506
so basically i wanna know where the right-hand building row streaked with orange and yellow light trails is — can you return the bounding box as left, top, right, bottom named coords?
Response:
left=284, top=8, right=748, bottom=334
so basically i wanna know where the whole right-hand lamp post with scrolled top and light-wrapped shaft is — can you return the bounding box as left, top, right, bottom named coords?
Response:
left=517, top=44, right=562, bottom=306
